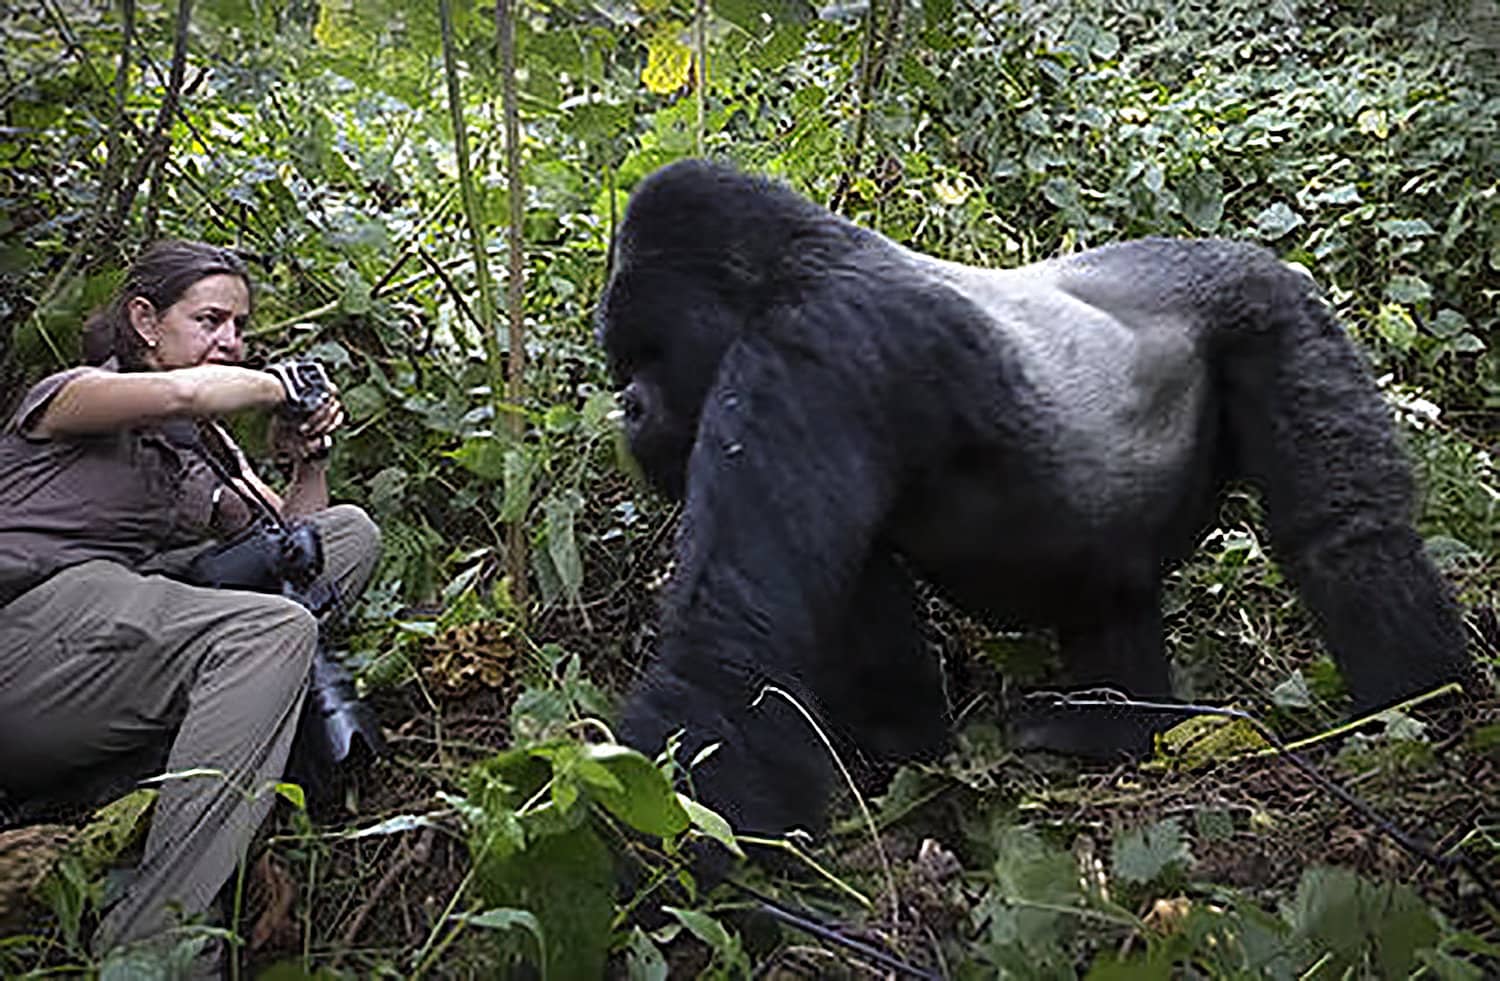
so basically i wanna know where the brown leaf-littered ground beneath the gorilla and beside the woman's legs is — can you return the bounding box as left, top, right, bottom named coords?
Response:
left=0, top=522, right=1500, bottom=978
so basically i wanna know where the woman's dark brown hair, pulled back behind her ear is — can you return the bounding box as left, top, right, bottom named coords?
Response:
left=83, top=239, right=251, bottom=371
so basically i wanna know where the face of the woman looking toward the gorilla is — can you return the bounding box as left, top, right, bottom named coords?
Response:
left=129, top=273, right=251, bottom=371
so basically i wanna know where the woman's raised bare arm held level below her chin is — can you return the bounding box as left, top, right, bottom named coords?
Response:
left=33, top=365, right=287, bottom=437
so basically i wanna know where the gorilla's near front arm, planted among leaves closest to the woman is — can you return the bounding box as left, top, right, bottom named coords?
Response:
left=623, top=338, right=900, bottom=833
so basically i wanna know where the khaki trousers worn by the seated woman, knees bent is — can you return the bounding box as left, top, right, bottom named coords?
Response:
left=0, top=504, right=380, bottom=951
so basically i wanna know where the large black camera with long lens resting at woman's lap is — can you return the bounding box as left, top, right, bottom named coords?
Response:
left=185, top=519, right=386, bottom=786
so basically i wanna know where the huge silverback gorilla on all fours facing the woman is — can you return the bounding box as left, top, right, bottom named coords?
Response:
left=599, top=161, right=1469, bottom=833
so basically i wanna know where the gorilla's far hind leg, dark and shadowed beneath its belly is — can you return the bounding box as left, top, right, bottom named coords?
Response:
left=1011, top=585, right=1181, bottom=759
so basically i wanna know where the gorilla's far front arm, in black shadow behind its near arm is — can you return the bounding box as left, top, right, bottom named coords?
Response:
left=813, top=551, right=948, bottom=767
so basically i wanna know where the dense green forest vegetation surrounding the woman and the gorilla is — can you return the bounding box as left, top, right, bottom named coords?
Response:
left=0, top=0, right=1500, bottom=978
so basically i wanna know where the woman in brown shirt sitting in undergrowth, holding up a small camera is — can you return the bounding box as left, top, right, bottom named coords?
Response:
left=0, top=242, right=378, bottom=951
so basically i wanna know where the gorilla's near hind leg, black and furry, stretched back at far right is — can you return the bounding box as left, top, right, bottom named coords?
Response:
left=1223, top=269, right=1469, bottom=710
